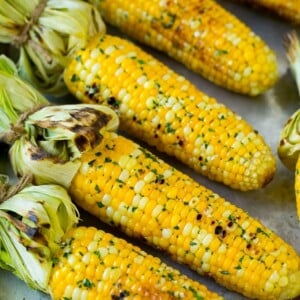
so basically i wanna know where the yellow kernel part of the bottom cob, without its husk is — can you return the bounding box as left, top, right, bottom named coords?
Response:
left=49, top=227, right=223, bottom=300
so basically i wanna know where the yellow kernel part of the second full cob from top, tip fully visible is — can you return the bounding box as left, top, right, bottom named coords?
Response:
left=65, top=35, right=275, bottom=190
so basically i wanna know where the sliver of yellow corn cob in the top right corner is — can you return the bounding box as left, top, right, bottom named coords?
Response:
left=235, top=0, right=300, bottom=24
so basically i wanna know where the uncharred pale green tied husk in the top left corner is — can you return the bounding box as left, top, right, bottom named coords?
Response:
left=0, top=0, right=106, bottom=95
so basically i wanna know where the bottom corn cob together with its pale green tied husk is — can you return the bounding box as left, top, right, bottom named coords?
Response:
left=0, top=176, right=223, bottom=300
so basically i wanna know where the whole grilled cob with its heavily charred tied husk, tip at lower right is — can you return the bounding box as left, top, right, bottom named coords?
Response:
left=0, top=56, right=300, bottom=299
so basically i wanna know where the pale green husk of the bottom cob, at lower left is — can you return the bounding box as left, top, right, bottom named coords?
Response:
left=0, top=175, right=79, bottom=292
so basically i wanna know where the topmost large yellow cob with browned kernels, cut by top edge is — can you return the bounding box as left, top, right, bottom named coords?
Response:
left=89, top=0, right=278, bottom=95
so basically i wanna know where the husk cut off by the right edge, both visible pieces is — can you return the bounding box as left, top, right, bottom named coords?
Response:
left=277, top=31, right=300, bottom=171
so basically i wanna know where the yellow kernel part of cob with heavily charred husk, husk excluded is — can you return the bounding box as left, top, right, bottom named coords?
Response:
left=69, top=132, right=300, bottom=300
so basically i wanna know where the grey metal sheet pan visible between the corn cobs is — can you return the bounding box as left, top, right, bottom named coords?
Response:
left=0, top=1, right=300, bottom=300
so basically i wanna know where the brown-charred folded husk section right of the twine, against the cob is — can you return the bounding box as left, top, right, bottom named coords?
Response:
left=9, top=104, right=118, bottom=187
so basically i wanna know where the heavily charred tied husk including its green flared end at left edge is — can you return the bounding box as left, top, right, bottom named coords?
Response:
left=0, top=55, right=119, bottom=187
